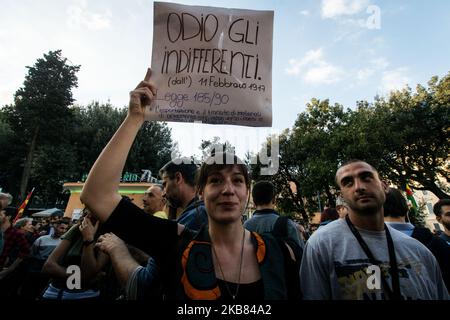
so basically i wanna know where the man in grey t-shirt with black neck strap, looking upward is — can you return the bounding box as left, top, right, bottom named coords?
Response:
left=300, top=160, right=450, bottom=300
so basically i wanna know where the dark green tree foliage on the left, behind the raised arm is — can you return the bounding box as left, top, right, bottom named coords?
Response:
left=0, top=51, right=172, bottom=203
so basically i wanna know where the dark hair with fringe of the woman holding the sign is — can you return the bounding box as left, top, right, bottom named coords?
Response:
left=196, top=152, right=250, bottom=193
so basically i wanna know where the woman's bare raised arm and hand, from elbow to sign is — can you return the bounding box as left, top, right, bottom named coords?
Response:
left=81, top=69, right=156, bottom=222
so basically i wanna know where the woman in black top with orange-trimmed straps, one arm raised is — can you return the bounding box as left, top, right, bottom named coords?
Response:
left=81, top=69, right=296, bottom=300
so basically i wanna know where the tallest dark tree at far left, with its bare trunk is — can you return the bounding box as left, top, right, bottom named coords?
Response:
left=4, top=50, right=80, bottom=199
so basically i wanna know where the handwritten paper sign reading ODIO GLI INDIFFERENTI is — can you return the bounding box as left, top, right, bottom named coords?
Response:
left=146, top=2, right=273, bottom=127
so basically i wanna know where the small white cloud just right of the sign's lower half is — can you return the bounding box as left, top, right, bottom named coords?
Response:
left=285, top=48, right=344, bottom=85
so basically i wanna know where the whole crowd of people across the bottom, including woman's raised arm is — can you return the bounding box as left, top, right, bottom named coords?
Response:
left=0, top=72, right=450, bottom=302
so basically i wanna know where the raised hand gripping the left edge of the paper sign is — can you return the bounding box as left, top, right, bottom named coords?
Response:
left=128, top=68, right=156, bottom=121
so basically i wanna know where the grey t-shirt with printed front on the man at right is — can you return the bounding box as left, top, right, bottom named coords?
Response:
left=300, top=219, right=450, bottom=300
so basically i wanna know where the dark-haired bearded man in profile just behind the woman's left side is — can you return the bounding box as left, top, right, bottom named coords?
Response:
left=159, top=158, right=208, bottom=230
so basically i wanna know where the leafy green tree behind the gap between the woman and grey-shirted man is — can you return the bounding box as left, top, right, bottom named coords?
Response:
left=252, top=99, right=347, bottom=224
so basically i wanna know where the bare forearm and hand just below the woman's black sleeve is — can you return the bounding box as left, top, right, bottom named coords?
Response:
left=96, top=233, right=139, bottom=288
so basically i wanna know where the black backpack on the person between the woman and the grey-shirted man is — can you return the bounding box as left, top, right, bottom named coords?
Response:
left=271, top=216, right=303, bottom=300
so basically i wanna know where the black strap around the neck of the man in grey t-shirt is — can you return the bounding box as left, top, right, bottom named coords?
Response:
left=345, top=215, right=402, bottom=300
